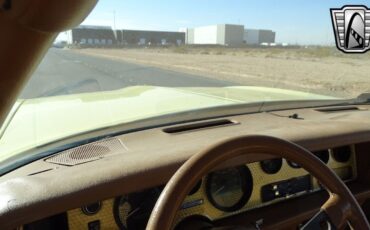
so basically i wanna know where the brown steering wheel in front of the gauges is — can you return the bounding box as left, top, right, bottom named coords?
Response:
left=147, top=136, right=370, bottom=230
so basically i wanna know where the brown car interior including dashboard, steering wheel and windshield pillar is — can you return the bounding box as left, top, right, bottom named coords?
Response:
left=0, top=0, right=370, bottom=230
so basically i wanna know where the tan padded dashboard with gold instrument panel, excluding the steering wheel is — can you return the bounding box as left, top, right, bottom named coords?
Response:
left=0, top=106, right=370, bottom=230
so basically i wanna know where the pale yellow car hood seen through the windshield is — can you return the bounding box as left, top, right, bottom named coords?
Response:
left=0, top=86, right=334, bottom=161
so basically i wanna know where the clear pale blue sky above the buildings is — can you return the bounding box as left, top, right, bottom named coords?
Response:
left=57, top=0, right=370, bottom=45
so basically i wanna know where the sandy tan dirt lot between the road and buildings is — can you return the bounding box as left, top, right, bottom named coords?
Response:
left=75, top=47, right=370, bottom=97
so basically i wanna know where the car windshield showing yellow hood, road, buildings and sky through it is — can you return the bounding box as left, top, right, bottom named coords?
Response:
left=0, top=0, right=370, bottom=161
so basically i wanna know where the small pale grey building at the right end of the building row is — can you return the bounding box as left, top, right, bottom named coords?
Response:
left=244, top=29, right=275, bottom=45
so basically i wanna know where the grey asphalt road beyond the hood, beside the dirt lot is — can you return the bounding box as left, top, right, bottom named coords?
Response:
left=20, top=48, right=231, bottom=98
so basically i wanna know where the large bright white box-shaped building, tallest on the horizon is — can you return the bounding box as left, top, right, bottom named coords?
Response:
left=185, top=24, right=244, bottom=46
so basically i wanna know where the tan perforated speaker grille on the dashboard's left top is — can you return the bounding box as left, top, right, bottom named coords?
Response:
left=45, top=138, right=127, bottom=166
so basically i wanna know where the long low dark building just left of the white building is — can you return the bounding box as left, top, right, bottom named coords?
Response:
left=116, top=30, right=185, bottom=45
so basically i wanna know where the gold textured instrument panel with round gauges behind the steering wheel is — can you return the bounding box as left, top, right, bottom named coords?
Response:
left=67, top=145, right=357, bottom=229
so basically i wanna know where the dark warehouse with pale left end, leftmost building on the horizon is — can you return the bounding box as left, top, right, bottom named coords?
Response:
left=67, top=25, right=116, bottom=46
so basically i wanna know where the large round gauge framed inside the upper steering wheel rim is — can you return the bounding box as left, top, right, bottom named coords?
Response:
left=206, top=166, right=253, bottom=212
